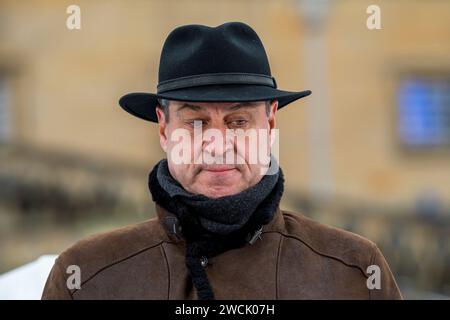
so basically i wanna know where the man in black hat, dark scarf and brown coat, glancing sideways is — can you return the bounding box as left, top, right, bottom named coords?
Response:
left=43, top=22, right=401, bottom=299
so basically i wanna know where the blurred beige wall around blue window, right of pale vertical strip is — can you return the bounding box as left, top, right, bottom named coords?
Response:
left=328, top=1, right=450, bottom=204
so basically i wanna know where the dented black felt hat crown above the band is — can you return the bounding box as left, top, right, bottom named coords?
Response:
left=158, top=22, right=271, bottom=83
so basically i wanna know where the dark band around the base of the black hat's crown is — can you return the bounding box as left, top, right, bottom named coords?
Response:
left=157, top=73, right=277, bottom=93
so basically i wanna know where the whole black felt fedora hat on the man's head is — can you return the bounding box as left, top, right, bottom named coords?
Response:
left=119, top=22, right=311, bottom=122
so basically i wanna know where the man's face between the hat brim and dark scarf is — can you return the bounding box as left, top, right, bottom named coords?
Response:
left=156, top=101, right=278, bottom=198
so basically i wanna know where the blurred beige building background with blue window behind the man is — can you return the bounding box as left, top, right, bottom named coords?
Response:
left=0, top=0, right=450, bottom=299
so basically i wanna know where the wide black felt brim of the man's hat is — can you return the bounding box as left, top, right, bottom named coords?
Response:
left=119, top=84, right=311, bottom=122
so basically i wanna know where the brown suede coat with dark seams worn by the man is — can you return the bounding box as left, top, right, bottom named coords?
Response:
left=42, top=206, right=401, bottom=299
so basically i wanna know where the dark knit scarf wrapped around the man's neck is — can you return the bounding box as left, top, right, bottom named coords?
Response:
left=148, top=159, right=284, bottom=300
